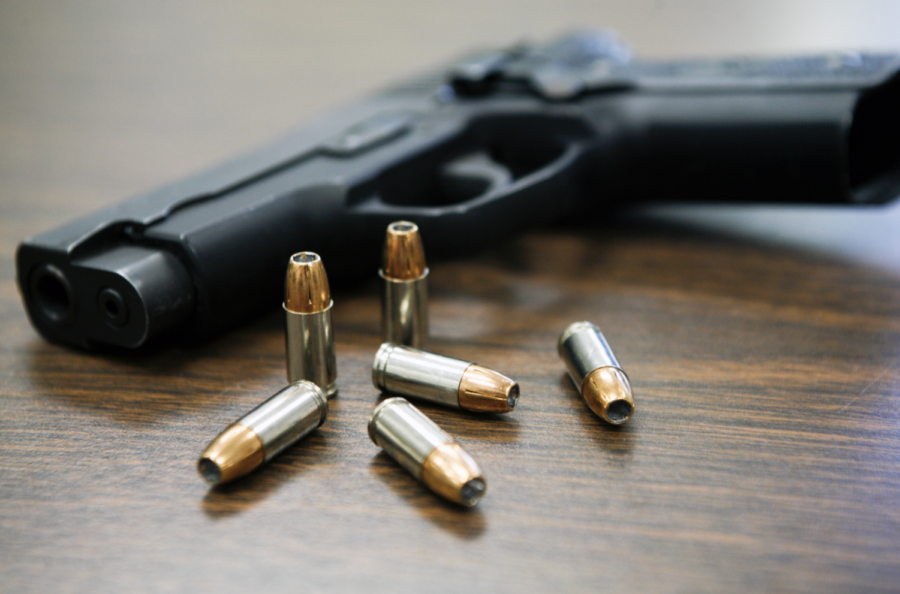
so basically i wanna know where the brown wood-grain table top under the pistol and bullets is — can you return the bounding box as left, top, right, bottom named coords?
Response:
left=0, top=2, right=900, bottom=592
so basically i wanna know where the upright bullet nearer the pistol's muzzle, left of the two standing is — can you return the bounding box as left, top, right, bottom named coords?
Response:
left=284, top=252, right=337, bottom=398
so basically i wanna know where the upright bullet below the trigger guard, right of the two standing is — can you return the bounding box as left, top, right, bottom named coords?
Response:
left=378, top=221, right=428, bottom=349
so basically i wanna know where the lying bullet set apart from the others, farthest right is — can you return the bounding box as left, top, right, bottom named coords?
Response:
left=558, top=322, right=634, bottom=425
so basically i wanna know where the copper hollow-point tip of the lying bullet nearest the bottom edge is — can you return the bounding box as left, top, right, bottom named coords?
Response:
left=422, top=442, right=487, bottom=507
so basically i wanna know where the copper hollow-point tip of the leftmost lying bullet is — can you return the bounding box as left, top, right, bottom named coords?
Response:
left=197, top=423, right=266, bottom=486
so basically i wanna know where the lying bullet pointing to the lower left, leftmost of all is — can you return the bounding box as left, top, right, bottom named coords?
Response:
left=197, top=380, right=328, bottom=486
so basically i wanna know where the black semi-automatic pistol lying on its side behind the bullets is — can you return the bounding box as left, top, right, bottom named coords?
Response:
left=16, top=32, right=900, bottom=348
